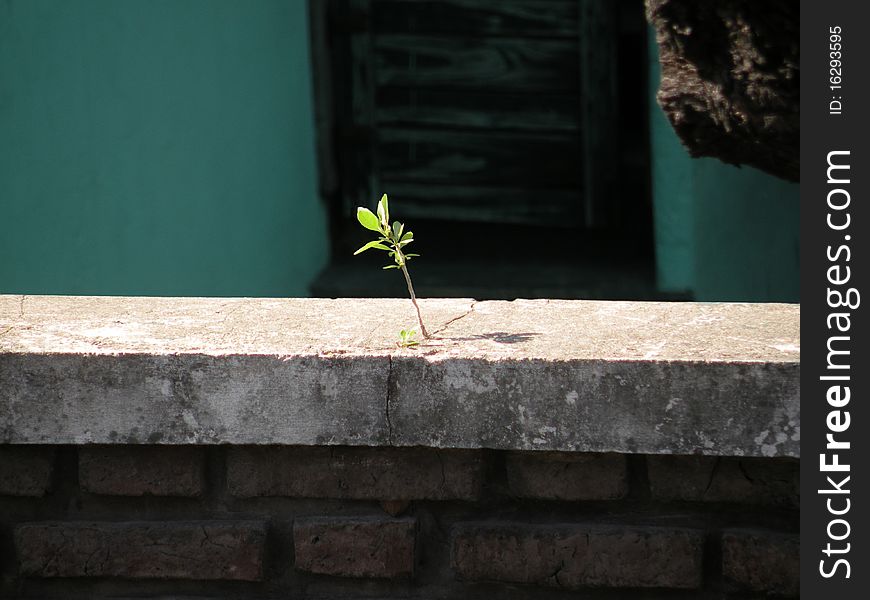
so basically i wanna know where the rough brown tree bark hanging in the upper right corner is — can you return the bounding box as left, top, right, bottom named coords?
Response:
left=647, top=0, right=800, bottom=181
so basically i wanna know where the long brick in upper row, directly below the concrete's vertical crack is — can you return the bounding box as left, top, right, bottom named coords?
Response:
left=227, top=446, right=483, bottom=500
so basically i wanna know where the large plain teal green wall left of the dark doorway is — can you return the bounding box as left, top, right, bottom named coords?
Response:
left=0, top=0, right=328, bottom=296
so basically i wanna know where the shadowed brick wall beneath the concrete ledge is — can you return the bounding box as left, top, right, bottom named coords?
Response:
left=0, top=446, right=799, bottom=600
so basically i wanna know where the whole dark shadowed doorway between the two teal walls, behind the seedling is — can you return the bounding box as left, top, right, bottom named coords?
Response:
left=310, top=0, right=655, bottom=299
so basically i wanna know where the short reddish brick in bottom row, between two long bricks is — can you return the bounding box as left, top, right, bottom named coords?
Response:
left=293, top=517, right=416, bottom=579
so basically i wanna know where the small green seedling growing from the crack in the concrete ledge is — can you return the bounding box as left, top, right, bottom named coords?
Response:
left=353, top=194, right=431, bottom=346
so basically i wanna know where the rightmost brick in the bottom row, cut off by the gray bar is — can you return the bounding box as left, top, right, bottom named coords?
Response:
left=722, top=531, right=800, bottom=597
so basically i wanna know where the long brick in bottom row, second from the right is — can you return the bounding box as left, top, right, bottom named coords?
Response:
left=452, top=523, right=703, bottom=589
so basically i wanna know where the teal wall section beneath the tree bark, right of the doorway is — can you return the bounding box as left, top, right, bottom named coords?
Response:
left=650, top=32, right=800, bottom=302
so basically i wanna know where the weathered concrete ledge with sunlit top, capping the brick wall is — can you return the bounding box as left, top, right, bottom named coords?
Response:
left=0, top=296, right=800, bottom=456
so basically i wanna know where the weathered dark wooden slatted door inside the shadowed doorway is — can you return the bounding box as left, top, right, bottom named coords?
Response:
left=316, top=0, right=617, bottom=226
